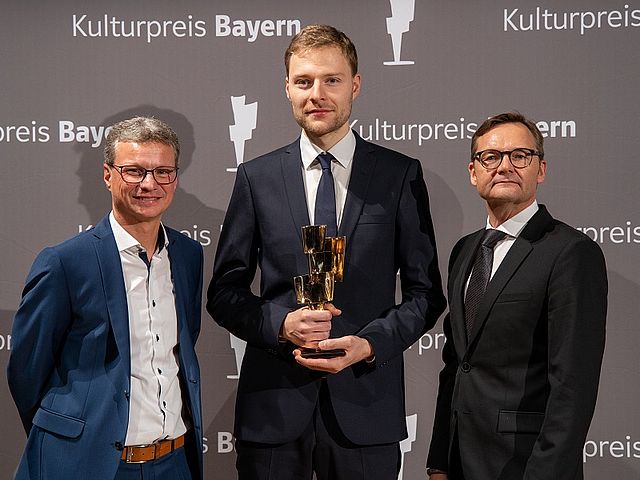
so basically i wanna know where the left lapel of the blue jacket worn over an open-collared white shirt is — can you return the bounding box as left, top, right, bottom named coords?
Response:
left=93, top=216, right=131, bottom=372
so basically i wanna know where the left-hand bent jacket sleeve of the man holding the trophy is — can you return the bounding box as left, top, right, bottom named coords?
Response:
left=207, top=164, right=290, bottom=348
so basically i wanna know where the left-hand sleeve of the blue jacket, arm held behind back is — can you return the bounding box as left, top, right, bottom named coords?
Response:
left=7, top=248, right=72, bottom=433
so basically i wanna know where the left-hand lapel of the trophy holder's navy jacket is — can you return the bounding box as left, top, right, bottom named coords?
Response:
left=280, top=138, right=311, bottom=242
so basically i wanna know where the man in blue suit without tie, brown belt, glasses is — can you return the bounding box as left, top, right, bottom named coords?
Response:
left=7, top=117, right=202, bottom=480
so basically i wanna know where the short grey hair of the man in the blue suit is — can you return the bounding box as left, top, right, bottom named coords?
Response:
left=104, top=117, right=180, bottom=167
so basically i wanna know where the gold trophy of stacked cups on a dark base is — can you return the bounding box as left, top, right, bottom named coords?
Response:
left=293, top=225, right=347, bottom=358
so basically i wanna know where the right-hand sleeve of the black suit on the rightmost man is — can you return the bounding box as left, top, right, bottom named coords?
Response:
left=524, top=239, right=607, bottom=479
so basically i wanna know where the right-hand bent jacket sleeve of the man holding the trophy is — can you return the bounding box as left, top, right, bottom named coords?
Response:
left=358, top=160, right=446, bottom=364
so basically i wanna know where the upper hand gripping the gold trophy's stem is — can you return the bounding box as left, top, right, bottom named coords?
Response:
left=281, top=303, right=342, bottom=348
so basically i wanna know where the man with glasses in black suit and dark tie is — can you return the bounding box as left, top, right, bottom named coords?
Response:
left=427, top=112, right=607, bottom=480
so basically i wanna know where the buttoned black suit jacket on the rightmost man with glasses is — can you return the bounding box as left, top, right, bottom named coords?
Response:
left=427, top=205, right=607, bottom=480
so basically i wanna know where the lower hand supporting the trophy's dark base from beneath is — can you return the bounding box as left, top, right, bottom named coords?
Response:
left=293, top=335, right=374, bottom=373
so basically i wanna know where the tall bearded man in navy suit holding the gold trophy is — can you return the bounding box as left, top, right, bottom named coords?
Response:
left=207, top=25, right=444, bottom=480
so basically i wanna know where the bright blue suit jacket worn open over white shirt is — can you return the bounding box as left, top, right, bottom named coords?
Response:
left=7, top=217, right=202, bottom=480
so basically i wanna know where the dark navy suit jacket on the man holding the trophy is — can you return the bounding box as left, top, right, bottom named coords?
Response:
left=207, top=135, right=444, bottom=445
